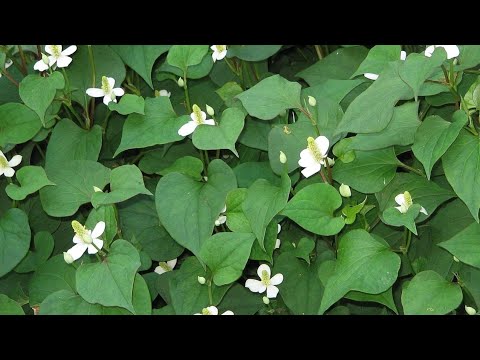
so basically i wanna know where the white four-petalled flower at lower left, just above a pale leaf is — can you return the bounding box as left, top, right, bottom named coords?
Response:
left=64, top=220, right=105, bottom=261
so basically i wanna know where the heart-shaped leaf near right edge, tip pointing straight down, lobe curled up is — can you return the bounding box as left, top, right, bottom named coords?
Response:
left=412, top=111, right=468, bottom=179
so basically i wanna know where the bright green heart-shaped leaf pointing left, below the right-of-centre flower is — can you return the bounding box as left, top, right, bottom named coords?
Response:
left=282, top=184, right=345, bottom=236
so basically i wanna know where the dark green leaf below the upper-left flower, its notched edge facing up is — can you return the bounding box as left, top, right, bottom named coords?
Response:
left=45, top=119, right=102, bottom=173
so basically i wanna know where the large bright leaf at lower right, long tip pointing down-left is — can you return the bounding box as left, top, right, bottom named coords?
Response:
left=319, top=229, right=401, bottom=314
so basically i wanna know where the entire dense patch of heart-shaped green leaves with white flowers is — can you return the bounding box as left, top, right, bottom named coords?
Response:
left=0, top=45, right=480, bottom=315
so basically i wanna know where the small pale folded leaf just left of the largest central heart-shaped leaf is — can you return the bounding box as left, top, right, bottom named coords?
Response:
left=92, top=165, right=152, bottom=208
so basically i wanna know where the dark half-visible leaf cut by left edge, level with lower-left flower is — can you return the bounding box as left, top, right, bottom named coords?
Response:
left=0, top=209, right=30, bottom=277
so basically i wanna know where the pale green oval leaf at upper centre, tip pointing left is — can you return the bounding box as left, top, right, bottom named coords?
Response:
left=237, top=75, right=301, bottom=120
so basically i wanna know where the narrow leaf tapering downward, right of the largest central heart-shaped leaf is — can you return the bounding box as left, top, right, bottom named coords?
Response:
left=242, top=174, right=291, bottom=250
